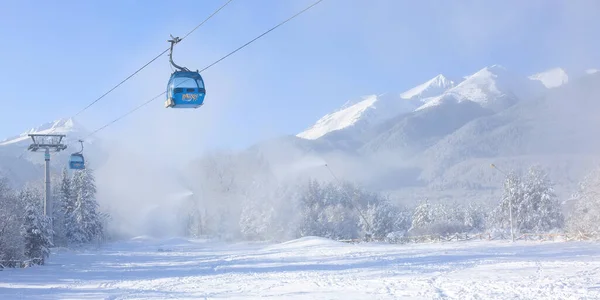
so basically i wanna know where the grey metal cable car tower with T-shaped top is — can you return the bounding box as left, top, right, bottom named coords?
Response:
left=27, top=134, right=67, bottom=223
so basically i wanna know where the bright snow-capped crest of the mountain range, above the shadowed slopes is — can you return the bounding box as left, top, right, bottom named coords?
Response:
left=297, top=65, right=562, bottom=140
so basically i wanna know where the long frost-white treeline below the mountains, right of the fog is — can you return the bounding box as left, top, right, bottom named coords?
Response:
left=180, top=155, right=600, bottom=240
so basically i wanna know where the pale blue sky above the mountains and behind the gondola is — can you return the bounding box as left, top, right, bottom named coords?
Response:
left=0, top=0, right=600, bottom=155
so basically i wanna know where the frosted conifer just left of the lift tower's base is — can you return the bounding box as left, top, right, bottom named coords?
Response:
left=19, top=188, right=53, bottom=264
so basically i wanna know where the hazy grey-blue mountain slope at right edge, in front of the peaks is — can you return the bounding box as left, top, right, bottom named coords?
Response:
left=419, top=73, right=600, bottom=193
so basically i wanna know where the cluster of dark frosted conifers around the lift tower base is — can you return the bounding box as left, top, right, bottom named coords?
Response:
left=0, top=169, right=108, bottom=267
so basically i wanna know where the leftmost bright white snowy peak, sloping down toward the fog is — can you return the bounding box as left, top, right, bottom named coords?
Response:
left=296, top=94, right=416, bottom=140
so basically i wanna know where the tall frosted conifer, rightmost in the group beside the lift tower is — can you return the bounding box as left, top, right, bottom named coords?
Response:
left=69, top=169, right=103, bottom=243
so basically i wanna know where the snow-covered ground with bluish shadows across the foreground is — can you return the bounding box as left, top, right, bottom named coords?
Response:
left=0, top=237, right=600, bottom=300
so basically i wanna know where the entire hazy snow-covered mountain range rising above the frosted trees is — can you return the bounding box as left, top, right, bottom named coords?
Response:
left=263, top=65, right=600, bottom=203
